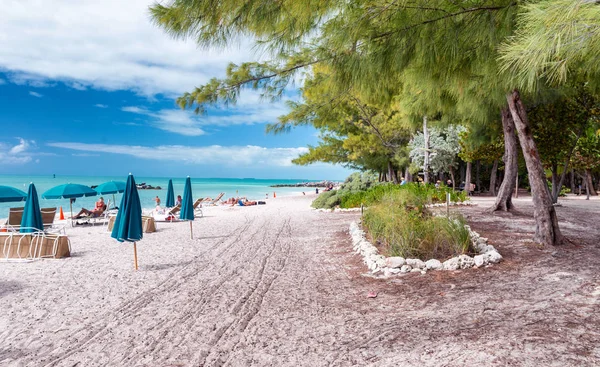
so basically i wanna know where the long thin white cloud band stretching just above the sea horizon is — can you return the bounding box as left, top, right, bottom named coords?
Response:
left=47, top=142, right=308, bottom=167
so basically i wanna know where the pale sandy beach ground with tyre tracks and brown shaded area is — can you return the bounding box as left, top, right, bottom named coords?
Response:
left=0, top=194, right=600, bottom=366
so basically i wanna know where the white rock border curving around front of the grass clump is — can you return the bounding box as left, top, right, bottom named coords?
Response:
left=349, top=222, right=502, bottom=277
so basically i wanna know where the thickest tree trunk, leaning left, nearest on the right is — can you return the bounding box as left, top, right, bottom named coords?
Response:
left=506, top=89, right=564, bottom=245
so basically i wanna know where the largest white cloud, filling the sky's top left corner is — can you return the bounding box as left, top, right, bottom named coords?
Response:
left=0, top=0, right=255, bottom=96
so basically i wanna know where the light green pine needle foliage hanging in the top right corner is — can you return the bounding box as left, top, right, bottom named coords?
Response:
left=500, top=0, right=600, bottom=91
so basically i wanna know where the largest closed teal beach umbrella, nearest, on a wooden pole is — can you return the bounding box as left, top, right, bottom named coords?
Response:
left=110, top=173, right=144, bottom=270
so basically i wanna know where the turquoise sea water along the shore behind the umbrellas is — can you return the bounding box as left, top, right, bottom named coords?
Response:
left=0, top=175, right=324, bottom=218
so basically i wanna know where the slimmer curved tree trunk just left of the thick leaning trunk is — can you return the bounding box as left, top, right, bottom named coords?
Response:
left=491, top=108, right=519, bottom=211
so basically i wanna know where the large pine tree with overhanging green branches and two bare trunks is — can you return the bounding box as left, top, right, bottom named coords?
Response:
left=151, top=0, right=562, bottom=244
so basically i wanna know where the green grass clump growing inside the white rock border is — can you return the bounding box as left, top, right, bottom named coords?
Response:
left=363, top=189, right=473, bottom=260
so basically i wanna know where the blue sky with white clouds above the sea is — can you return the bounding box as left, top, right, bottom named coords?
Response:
left=0, top=0, right=349, bottom=179
